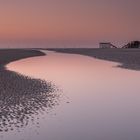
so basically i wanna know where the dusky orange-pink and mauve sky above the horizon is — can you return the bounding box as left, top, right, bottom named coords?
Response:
left=0, top=0, right=140, bottom=41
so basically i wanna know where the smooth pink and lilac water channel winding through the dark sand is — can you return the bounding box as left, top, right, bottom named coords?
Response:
left=8, top=52, right=140, bottom=140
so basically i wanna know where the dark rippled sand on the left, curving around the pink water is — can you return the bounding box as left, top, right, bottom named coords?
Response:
left=0, top=49, right=56, bottom=131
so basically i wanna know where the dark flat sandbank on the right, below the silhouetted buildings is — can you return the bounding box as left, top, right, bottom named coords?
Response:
left=48, top=48, right=140, bottom=70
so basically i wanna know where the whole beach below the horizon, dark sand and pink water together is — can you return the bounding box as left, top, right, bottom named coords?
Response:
left=0, top=48, right=140, bottom=140
